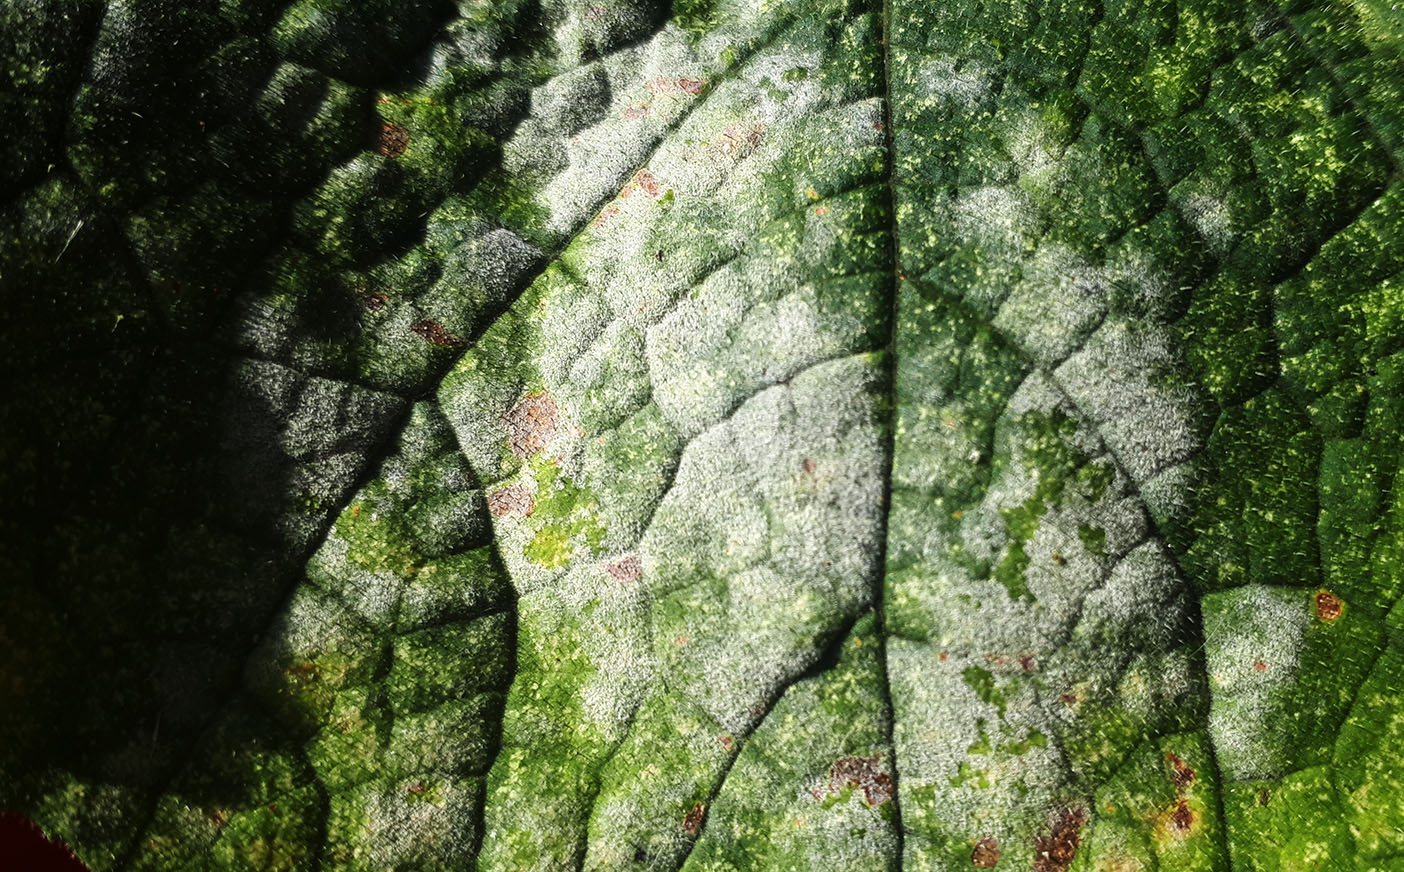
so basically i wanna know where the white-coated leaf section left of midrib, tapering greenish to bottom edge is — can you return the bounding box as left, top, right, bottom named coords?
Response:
left=587, top=355, right=883, bottom=869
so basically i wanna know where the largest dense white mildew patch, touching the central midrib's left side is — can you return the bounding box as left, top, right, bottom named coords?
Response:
left=639, top=357, right=882, bottom=730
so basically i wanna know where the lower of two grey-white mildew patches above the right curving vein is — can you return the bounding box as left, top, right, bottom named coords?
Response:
left=1056, top=320, right=1202, bottom=482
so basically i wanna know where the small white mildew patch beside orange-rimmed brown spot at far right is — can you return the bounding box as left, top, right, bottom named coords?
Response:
left=1200, top=584, right=1313, bottom=781
